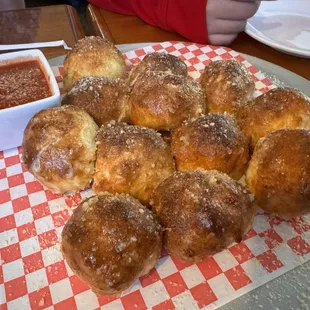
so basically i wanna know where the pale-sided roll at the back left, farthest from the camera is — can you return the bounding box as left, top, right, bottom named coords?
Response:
left=63, top=37, right=126, bottom=91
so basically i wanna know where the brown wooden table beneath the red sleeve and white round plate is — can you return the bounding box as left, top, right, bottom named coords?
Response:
left=87, top=4, right=310, bottom=80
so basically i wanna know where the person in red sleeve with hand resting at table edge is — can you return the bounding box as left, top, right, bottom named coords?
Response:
left=89, top=0, right=260, bottom=45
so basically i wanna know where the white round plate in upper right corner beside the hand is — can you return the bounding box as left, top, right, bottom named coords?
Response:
left=245, top=0, right=310, bottom=58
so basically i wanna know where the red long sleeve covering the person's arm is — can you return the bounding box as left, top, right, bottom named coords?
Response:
left=89, top=0, right=208, bottom=43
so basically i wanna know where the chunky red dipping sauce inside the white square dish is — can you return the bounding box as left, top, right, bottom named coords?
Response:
left=0, top=60, right=52, bottom=110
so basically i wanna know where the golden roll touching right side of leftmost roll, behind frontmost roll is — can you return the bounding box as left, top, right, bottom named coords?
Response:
left=93, top=122, right=175, bottom=203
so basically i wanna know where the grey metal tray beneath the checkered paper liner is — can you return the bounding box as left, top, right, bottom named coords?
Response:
left=49, top=42, right=310, bottom=310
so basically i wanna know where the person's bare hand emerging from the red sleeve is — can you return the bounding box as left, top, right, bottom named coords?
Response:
left=206, top=0, right=260, bottom=45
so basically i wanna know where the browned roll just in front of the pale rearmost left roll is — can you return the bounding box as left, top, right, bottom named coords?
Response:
left=61, top=76, right=130, bottom=126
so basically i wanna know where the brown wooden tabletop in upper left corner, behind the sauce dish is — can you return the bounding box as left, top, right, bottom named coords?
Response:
left=0, top=5, right=85, bottom=58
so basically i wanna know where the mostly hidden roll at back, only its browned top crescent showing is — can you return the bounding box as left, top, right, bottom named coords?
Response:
left=129, top=52, right=187, bottom=85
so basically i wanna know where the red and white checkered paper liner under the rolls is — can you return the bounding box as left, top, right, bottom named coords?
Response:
left=0, top=42, right=310, bottom=310
